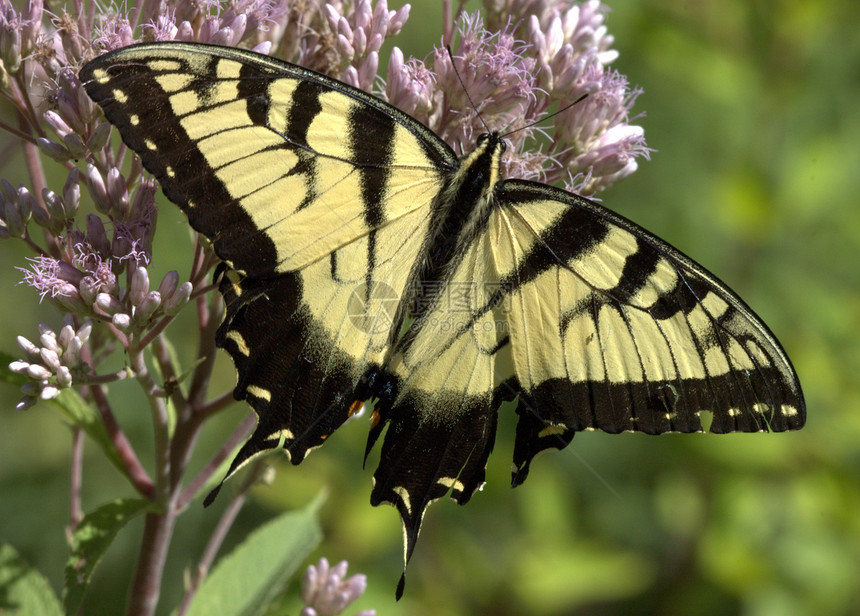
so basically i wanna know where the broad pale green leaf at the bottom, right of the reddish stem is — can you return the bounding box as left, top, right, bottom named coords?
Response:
left=182, top=493, right=325, bottom=616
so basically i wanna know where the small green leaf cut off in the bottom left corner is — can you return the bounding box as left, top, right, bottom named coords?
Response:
left=0, top=543, right=63, bottom=616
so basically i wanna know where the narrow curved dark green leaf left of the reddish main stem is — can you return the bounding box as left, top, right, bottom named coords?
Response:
left=63, top=498, right=155, bottom=614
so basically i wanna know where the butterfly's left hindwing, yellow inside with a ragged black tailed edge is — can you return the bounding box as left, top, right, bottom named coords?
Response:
left=212, top=205, right=434, bottom=473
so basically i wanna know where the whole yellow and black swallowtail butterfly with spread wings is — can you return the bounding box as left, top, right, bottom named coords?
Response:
left=80, top=43, right=806, bottom=596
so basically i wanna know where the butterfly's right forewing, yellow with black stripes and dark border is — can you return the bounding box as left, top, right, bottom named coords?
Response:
left=495, top=181, right=805, bottom=483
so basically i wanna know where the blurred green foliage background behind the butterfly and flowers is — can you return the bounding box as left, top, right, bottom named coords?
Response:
left=0, top=0, right=860, bottom=616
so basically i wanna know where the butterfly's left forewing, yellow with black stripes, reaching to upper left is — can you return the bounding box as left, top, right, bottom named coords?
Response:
left=81, top=43, right=456, bottom=276
